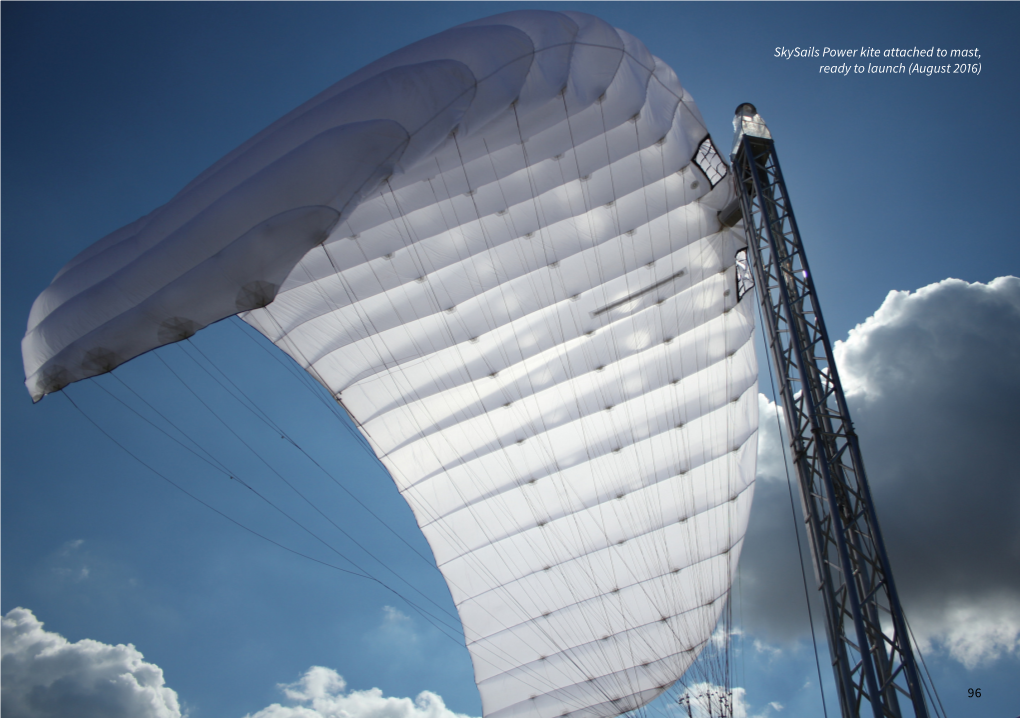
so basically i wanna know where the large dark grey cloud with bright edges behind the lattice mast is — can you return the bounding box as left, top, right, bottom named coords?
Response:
left=742, top=277, right=1020, bottom=667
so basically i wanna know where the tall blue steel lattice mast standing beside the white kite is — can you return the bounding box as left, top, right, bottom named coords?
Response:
left=721, top=104, right=928, bottom=718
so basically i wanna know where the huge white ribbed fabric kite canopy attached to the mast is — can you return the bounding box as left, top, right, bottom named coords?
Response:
left=23, top=10, right=758, bottom=718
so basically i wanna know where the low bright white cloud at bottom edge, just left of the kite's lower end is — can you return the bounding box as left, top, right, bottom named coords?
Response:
left=246, top=666, right=481, bottom=718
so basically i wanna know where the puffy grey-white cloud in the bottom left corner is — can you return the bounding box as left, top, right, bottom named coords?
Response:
left=0, top=608, right=182, bottom=718
